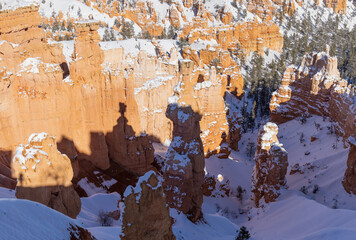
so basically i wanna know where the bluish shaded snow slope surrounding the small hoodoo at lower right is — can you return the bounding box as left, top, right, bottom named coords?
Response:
left=203, top=116, right=356, bottom=240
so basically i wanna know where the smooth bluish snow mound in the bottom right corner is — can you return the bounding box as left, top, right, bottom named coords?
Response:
left=246, top=193, right=356, bottom=240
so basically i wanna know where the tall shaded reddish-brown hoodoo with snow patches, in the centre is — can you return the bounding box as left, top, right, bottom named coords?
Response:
left=163, top=104, right=205, bottom=222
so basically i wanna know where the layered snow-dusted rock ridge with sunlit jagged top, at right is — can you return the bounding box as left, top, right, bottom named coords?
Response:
left=270, top=50, right=356, bottom=139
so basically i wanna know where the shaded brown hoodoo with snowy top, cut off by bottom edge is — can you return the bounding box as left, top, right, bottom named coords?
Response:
left=119, top=171, right=176, bottom=240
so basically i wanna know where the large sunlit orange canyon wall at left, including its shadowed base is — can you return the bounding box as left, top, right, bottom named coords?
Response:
left=0, top=6, right=238, bottom=187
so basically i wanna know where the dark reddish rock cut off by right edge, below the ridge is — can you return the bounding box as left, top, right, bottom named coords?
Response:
left=342, top=137, right=356, bottom=195
